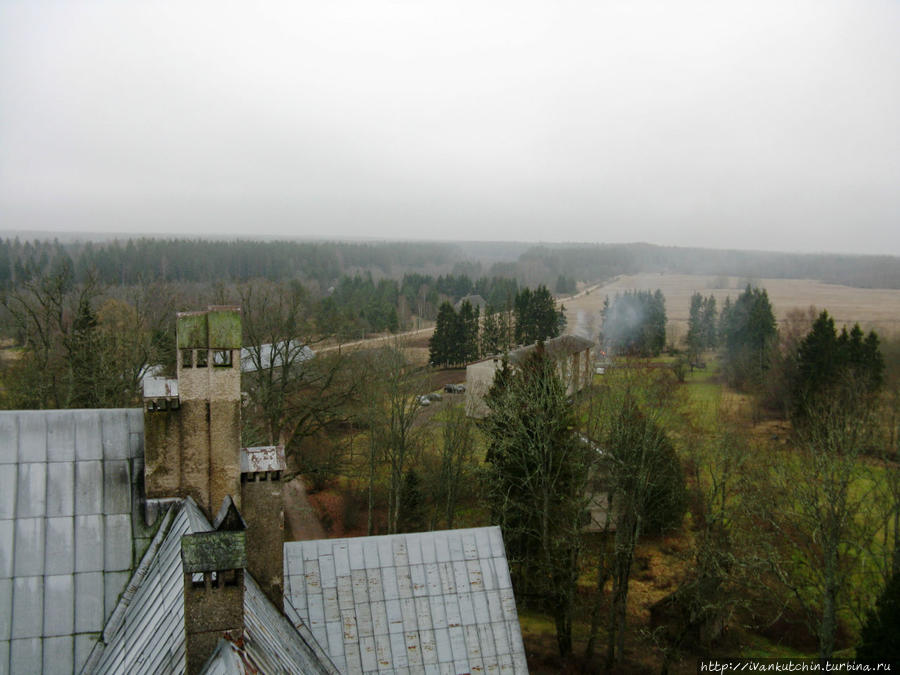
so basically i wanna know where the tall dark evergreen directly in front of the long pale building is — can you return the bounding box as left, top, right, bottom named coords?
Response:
left=485, top=347, right=592, bottom=656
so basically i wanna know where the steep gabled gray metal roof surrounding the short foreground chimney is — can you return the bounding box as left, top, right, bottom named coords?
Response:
left=85, top=498, right=338, bottom=674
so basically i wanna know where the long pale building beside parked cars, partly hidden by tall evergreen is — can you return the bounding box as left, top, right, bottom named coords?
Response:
left=466, top=335, right=597, bottom=418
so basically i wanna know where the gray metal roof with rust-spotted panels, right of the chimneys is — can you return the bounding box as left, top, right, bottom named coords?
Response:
left=284, top=527, right=528, bottom=674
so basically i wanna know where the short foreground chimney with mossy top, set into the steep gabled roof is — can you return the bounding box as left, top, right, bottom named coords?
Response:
left=181, top=497, right=247, bottom=675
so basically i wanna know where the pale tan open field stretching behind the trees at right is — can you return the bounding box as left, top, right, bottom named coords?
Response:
left=565, top=274, right=900, bottom=338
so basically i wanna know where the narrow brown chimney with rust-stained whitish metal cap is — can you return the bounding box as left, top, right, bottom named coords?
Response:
left=241, top=445, right=286, bottom=611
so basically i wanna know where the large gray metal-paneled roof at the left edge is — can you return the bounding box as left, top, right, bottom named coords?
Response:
left=0, top=409, right=149, bottom=673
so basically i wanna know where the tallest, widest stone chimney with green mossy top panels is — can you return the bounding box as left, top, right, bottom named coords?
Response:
left=144, top=306, right=241, bottom=518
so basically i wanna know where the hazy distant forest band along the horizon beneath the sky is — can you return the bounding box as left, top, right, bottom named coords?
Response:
left=0, top=238, right=900, bottom=295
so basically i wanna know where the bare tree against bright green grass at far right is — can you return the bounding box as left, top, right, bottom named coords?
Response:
left=757, top=390, right=886, bottom=658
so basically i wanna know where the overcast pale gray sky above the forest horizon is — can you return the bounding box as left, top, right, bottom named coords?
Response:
left=0, top=0, right=900, bottom=254
